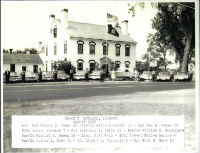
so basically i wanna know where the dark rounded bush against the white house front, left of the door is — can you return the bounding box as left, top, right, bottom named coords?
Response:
left=57, top=60, right=76, bottom=74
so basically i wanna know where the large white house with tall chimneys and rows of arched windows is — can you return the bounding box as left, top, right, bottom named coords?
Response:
left=39, top=9, right=136, bottom=74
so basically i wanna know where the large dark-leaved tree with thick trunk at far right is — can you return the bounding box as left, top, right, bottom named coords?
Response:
left=152, top=2, right=195, bottom=72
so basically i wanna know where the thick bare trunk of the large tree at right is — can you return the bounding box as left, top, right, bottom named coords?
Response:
left=181, top=35, right=192, bottom=72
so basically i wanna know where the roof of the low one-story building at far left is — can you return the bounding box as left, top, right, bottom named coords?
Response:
left=3, top=53, right=43, bottom=65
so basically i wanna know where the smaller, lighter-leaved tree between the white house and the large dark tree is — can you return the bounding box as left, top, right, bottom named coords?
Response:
left=145, top=32, right=172, bottom=71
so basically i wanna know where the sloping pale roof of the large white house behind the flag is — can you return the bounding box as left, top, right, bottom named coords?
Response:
left=56, top=19, right=137, bottom=44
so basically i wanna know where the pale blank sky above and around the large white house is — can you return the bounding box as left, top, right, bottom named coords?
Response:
left=1, top=1, right=156, bottom=60
